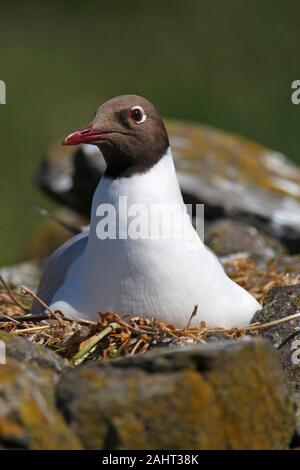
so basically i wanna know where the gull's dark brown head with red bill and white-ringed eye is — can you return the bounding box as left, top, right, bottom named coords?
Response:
left=64, top=95, right=169, bottom=178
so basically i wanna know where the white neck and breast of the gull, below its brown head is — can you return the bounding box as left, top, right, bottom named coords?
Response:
left=52, top=150, right=260, bottom=326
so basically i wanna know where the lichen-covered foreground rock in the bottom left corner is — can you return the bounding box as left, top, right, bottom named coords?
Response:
left=0, top=332, right=81, bottom=450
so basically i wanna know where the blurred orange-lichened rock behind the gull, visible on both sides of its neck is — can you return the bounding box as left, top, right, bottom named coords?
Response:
left=36, top=120, right=300, bottom=252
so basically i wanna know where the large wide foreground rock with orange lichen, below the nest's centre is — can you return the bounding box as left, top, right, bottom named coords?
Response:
left=57, top=340, right=294, bottom=450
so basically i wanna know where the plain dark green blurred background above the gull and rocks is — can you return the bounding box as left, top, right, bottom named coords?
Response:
left=0, top=0, right=300, bottom=265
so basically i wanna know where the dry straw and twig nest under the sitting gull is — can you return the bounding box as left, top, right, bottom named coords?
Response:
left=0, top=257, right=300, bottom=366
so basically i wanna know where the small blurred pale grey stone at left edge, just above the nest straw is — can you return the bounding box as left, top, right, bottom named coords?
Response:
left=0, top=261, right=41, bottom=291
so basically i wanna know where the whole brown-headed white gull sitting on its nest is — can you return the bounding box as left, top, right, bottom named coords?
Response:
left=33, top=95, right=260, bottom=327
